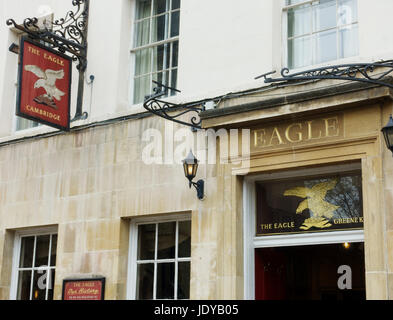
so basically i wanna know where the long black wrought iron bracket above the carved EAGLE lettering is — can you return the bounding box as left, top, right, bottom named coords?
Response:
left=255, top=60, right=393, bottom=88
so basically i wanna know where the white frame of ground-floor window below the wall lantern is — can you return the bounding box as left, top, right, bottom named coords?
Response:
left=126, top=213, right=192, bottom=300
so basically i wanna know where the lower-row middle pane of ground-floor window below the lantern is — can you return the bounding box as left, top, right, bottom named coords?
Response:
left=156, top=263, right=175, bottom=299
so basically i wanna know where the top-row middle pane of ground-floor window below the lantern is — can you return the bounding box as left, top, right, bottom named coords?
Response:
left=157, top=222, right=176, bottom=259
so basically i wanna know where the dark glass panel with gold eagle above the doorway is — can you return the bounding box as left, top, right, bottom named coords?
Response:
left=256, top=172, right=363, bottom=236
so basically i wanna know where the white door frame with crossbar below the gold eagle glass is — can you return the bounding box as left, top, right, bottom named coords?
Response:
left=243, top=162, right=364, bottom=300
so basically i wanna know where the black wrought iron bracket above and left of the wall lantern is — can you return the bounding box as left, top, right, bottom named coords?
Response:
left=143, top=81, right=204, bottom=129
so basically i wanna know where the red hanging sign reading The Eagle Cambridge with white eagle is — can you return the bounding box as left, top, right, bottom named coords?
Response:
left=16, top=37, right=72, bottom=131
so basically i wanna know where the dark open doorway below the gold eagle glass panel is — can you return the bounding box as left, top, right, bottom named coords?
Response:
left=255, top=242, right=365, bottom=300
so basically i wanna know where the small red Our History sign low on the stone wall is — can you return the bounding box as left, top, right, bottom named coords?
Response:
left=63, top=278, right=105, bottom=300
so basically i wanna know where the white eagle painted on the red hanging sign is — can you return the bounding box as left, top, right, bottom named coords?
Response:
left=25, top=65, right=65, bottom=108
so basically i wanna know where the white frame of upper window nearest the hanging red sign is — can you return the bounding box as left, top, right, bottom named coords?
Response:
left=130, top=0, right=181, bottom=105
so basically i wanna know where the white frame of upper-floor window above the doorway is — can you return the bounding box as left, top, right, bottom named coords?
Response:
left=281, top=0, right=360, bottom=71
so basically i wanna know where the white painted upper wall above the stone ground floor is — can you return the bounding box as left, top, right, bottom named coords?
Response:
left=0, top=0, right=393, bottom=141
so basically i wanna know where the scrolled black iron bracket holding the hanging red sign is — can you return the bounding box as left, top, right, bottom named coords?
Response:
left=6, top=0, right=90, bottom=121
